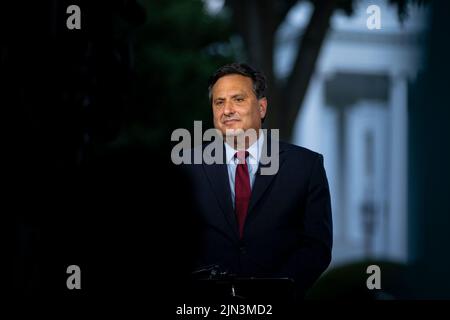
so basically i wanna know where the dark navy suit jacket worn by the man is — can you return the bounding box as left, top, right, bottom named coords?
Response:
left=187, top=131, right=332, bottom=294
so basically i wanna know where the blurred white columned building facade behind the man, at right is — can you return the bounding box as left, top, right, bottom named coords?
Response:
left=275, top=1, right=427, bottom=265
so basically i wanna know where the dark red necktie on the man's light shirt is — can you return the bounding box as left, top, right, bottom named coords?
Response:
left=234, top=151, right=251, bottom=238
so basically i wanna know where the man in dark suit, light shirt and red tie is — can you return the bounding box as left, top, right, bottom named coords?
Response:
left=188, top=63, right=332, bottom=296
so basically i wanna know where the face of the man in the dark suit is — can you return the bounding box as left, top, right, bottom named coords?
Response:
left=212, top=74, right=267, bottom=135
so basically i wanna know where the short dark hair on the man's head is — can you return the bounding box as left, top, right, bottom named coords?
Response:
left=208, top=62, right=267, bottom=100
